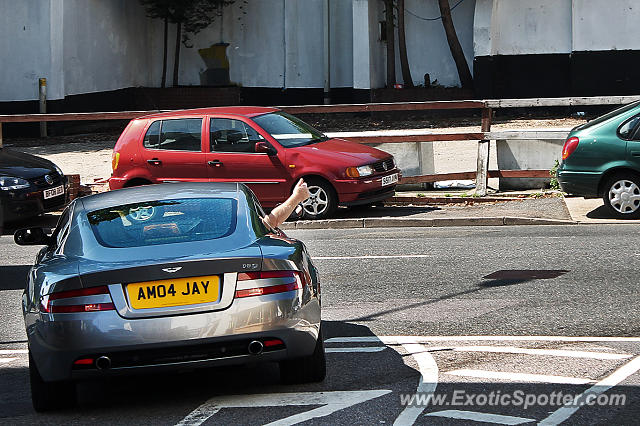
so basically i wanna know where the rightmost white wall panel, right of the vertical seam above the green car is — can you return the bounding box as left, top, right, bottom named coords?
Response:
left=572, top=0, right=640, bottom=51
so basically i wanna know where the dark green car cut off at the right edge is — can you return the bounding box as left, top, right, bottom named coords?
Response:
left=558, top=101, right=640, bottom=219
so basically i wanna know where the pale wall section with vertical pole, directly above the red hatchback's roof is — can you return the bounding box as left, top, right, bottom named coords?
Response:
left=175, top=0, right=353, bottom=88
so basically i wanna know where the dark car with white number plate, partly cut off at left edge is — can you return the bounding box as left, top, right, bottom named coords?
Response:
left=0, top=148, right=68, bottom=228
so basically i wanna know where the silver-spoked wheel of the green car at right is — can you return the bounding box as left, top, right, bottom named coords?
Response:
left=602, top=174, right=640, bottom=219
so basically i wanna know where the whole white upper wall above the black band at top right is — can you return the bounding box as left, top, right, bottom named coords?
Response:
left=473, top=0, right=640, bottom=56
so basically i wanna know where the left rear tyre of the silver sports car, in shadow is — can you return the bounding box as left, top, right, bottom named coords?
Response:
left=29, top=352, right=76, bottom=412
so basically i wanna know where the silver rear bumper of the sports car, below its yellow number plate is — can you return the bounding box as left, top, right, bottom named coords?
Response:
left=25, top=290, right=320, bottom=381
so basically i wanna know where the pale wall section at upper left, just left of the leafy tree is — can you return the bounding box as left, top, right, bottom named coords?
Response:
left=60, top=0, right=162, bottom=95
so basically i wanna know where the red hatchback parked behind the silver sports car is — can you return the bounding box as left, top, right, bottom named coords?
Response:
left=109, top=107, right=400, bottom=219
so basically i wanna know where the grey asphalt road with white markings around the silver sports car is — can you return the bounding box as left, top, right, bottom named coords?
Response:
left=0, top=225, right=640, bottom=425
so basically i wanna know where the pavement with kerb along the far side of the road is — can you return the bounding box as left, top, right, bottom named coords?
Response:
left=4, top=189, right=638, bottom=234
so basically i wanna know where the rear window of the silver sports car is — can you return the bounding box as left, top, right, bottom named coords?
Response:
left=88, top=198, right=237, bottom=248
